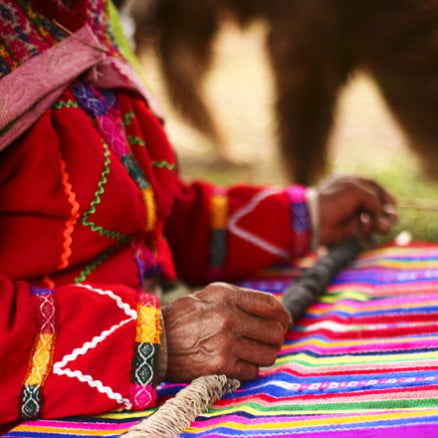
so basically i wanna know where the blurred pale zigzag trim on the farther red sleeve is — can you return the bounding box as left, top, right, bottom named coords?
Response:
left=228, top=188, right=291, bottom=259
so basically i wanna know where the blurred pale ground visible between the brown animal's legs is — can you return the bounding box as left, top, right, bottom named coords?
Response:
left=140, top=24, right=438, bottom=241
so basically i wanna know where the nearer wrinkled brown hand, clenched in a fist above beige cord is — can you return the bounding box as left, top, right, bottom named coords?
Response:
left=162, top=283, right=291, bottom=382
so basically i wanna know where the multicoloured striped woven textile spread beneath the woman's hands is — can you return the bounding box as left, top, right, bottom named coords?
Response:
left=5, top=243, right=438, bottom=438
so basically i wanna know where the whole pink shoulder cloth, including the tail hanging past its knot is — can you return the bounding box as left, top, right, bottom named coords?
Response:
left=0, top=25, right=161, bottom=151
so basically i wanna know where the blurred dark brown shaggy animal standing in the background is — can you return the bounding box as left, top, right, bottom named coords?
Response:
left=131, top=0, right=438, bottom=184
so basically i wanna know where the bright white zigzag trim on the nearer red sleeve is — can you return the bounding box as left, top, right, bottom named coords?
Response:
left=53, top=284, right=137, bottom=410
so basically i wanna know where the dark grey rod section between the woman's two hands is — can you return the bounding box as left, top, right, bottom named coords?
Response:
left=282, top=237, right=363, bottom=324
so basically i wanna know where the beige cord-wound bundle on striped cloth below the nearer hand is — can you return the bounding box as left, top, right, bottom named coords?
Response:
left=121, top=374, right=240, bottom=438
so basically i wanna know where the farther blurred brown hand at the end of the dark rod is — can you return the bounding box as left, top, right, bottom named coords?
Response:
left=317, top=175, right=397, bottom=245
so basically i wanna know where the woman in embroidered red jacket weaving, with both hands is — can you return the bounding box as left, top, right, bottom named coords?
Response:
left=0, top=0, right=395, bottom=431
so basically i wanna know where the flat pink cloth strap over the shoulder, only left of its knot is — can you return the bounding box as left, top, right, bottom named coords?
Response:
left=0, top=25, right=105, bottom=150
